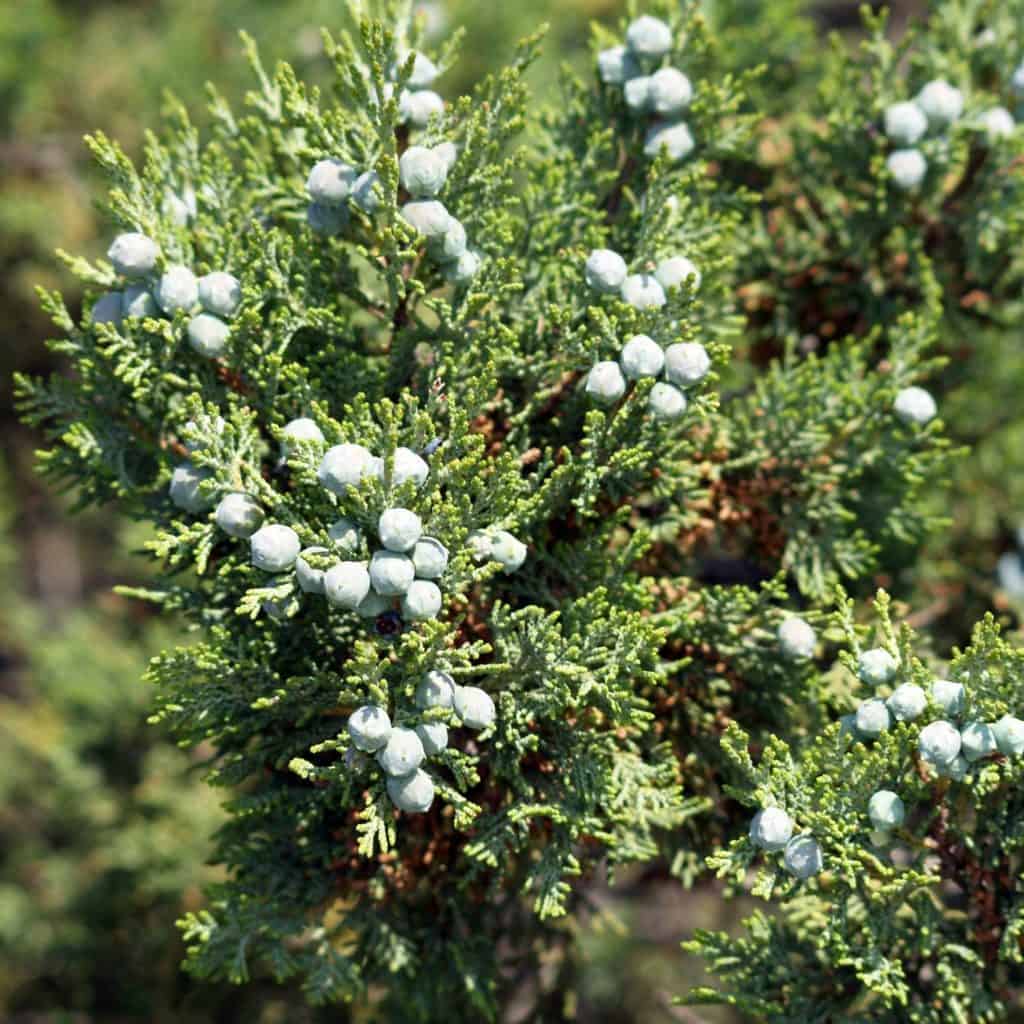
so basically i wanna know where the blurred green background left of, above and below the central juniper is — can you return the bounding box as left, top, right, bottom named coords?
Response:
left=0, top=0, right=974, bottom=1024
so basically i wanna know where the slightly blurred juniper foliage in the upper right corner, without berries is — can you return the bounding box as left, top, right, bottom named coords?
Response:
left=744, top=2, right=1021, bottom=354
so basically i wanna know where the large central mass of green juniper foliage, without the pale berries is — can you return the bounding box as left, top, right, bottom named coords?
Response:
left=19, top=0, right=1018, bottom=1020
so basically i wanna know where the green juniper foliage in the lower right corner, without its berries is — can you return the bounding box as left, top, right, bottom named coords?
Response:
left=689, top=589, right=1024, bottom=1022
